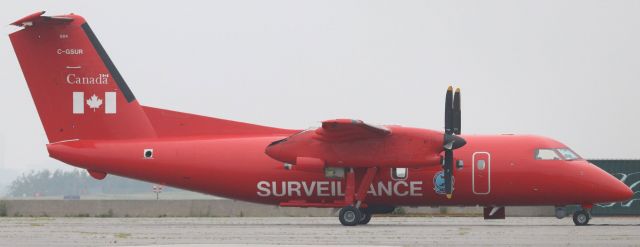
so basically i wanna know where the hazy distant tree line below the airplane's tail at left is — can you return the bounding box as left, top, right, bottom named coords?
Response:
left=7, top=169, right=168, bottom=197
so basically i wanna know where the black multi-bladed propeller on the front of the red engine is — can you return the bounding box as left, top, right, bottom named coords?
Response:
left=442, top=86, right=467, bottom=199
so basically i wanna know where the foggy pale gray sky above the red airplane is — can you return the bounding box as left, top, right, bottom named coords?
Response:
left=0, top=0, right=640, bottom=175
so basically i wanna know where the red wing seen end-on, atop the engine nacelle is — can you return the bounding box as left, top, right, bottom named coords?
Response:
left=315, top=119, right=391, bottom=142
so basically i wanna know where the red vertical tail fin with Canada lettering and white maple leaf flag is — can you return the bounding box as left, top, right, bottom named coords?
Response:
left=9, top=11, right=156, bottom=143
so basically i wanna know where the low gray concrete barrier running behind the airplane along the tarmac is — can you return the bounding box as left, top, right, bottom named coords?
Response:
left=0, top=200, right=554, bottom=217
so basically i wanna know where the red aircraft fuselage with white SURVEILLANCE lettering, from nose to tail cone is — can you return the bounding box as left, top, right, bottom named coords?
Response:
left=48, top=128, right=627, bottom=206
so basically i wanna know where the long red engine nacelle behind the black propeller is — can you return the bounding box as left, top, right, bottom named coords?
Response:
left=265, top=127, right=443, bottom=170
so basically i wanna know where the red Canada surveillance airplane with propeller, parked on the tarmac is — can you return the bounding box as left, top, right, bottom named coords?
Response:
left=9, top=11, right=633, bottom=226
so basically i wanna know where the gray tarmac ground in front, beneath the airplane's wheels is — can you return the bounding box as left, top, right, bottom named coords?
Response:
left=0, top=216, right=640, bottom=247
